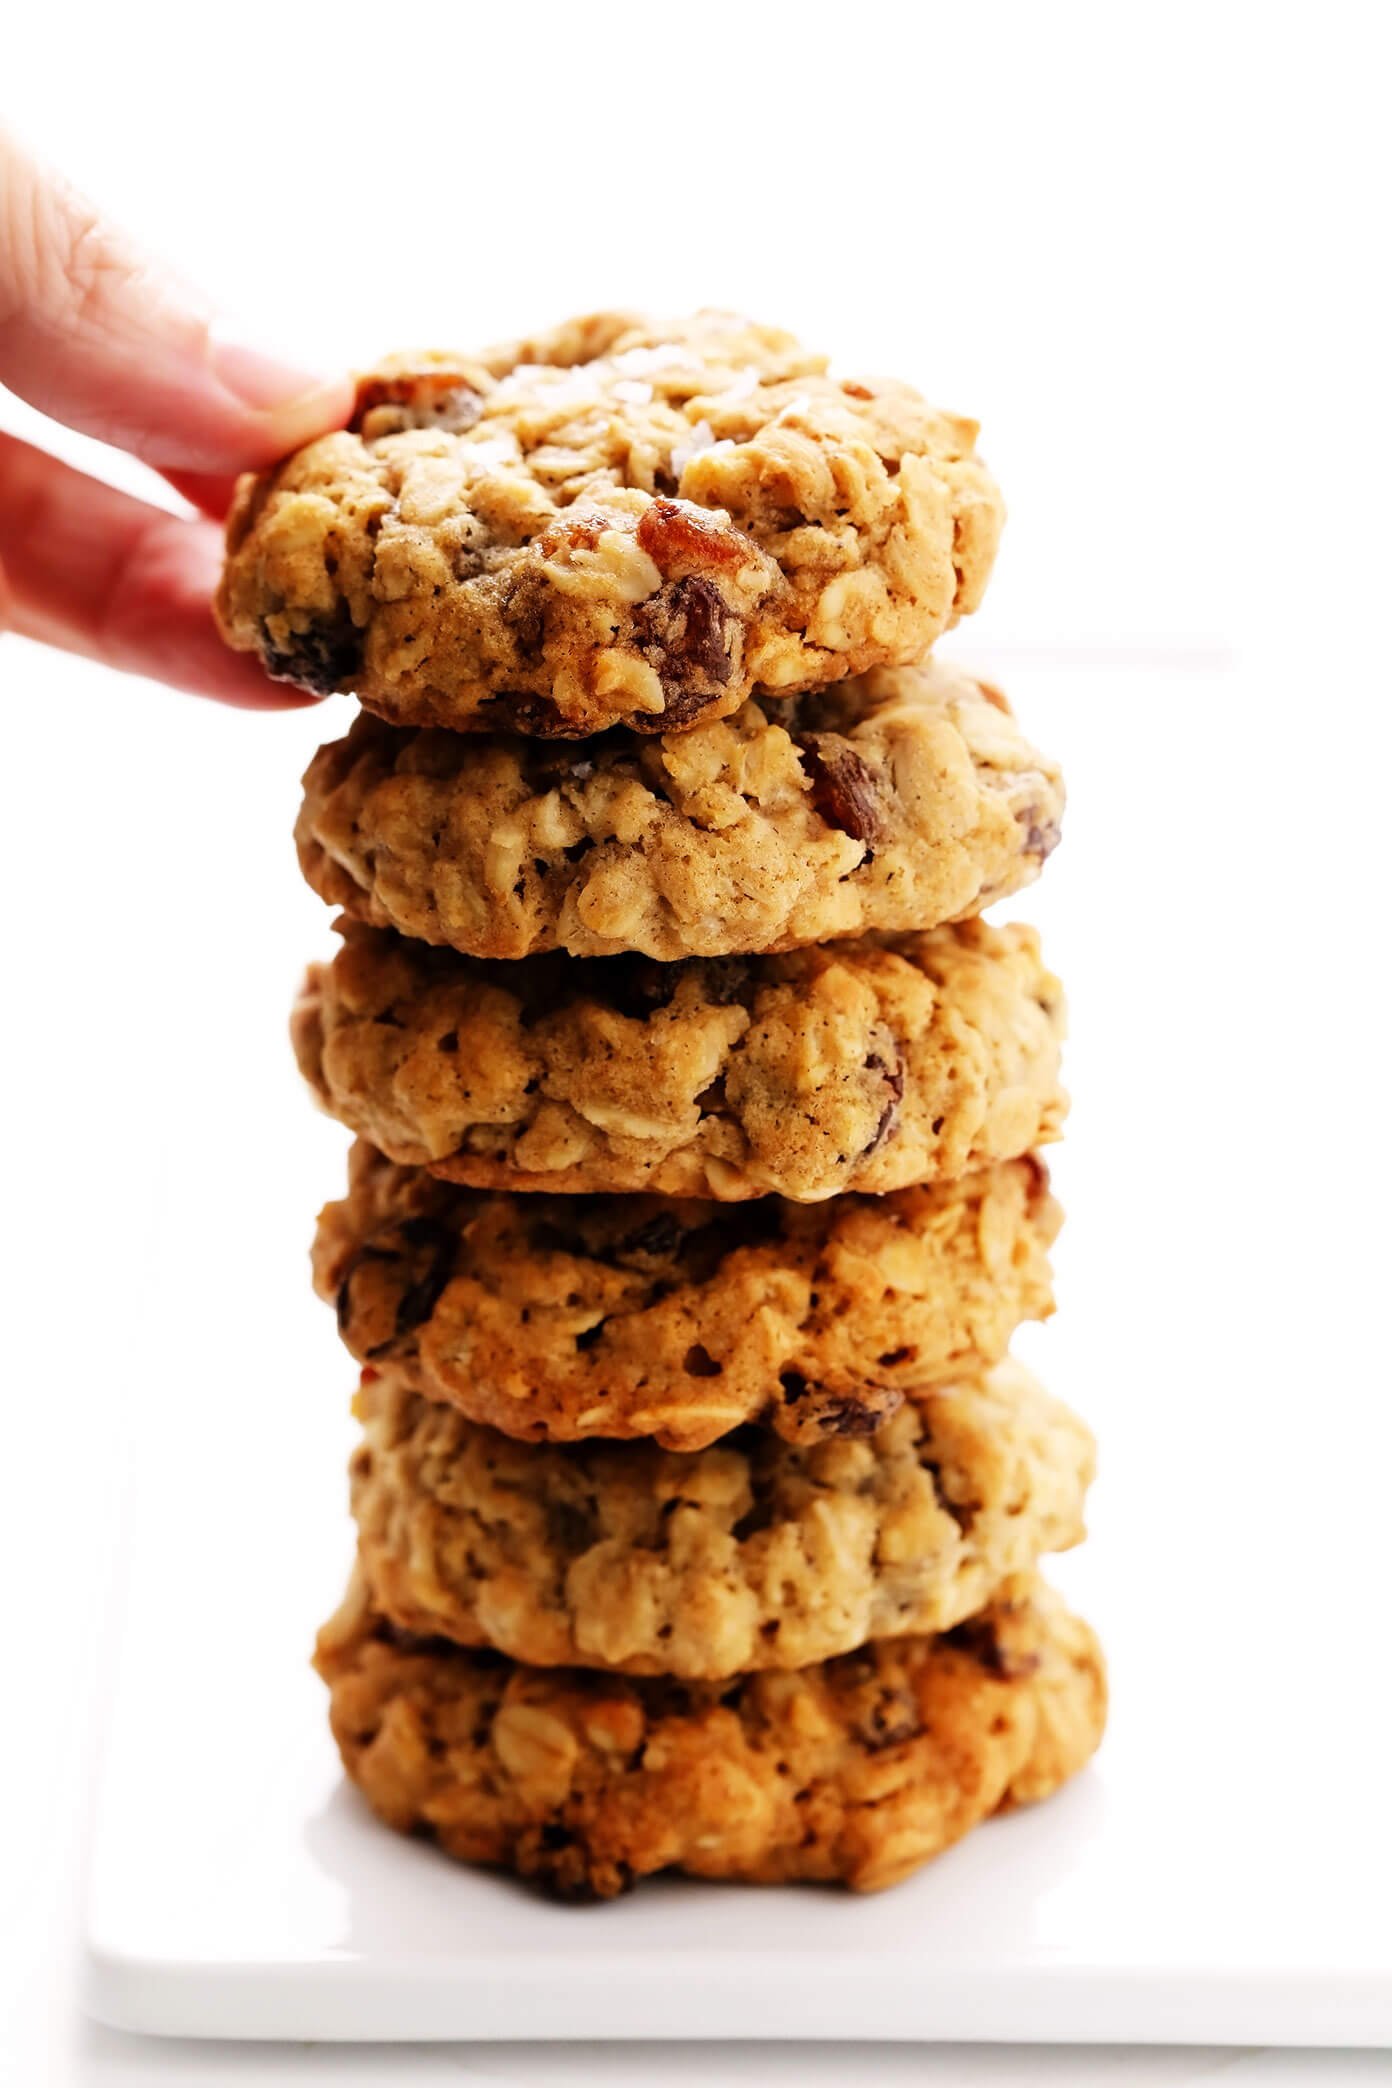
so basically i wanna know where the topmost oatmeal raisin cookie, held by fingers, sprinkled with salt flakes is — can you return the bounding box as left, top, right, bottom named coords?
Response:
left=217, top=311, right=1002, bottom=737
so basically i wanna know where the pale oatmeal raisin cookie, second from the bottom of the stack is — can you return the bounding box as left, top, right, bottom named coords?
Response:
left=351, top=1363, right=1094, bottom=1681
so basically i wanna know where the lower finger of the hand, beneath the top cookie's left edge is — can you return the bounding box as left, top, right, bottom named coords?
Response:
left=0, top=434, right=321, bottom=710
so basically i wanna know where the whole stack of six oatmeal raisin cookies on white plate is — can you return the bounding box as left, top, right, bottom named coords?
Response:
left=219, top=313, right=1104, bottom=1896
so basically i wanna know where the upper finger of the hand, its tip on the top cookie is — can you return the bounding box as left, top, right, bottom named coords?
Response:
left=0, top=132, right=353, bottom=476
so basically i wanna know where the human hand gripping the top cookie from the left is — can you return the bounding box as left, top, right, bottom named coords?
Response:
left=0, top=132, right=353, bottom=710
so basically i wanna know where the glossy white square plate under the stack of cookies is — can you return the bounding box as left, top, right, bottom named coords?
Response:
left=78, top=670, right=1392, bottom=2044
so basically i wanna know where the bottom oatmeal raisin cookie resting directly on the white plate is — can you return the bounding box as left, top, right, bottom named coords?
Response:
left=315, top=1574, right=1106, bottom=1900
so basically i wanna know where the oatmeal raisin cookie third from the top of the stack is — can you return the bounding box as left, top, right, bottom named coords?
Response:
left=292, top=921, right=1066, bottom=1203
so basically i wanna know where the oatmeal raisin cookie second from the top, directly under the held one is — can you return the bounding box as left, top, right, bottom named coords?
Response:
left=296, top=662, right=1062, bottom=960
